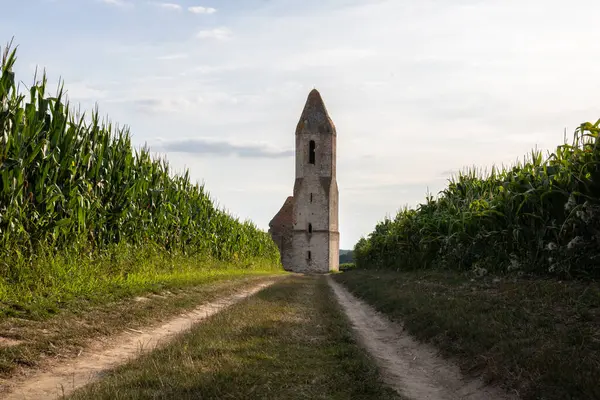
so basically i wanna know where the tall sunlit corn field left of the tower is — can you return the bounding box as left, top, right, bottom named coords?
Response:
left=0, top=46, right=279, bottom=281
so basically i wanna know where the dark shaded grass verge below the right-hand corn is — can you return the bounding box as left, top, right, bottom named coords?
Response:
left=334, top=270, right=600, bottom=400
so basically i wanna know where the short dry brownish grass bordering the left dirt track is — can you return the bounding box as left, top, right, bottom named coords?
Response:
left=0, top=269, right=281, bottom=378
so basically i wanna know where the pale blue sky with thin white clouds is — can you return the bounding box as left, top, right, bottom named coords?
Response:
left=0, top=0, right=600, bottom=249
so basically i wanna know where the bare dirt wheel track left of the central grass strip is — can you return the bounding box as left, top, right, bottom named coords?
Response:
left=0, top=280, right=275, bottom=400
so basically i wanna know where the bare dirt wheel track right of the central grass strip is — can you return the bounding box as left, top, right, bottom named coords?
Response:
left=327, top=276, right=517, bottom=400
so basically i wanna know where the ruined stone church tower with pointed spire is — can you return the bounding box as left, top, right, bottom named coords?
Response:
left=269, top=89, right=340, bottom=273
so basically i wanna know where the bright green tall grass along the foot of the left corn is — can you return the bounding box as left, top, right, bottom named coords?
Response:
left=0, top=246, right=283, bottom=320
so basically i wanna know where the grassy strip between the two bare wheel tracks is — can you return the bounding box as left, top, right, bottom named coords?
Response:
left=70, top=276, right=396, bottom=400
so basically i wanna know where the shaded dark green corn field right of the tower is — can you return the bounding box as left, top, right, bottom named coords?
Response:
left=354, top=121, right=600, bottom=278
